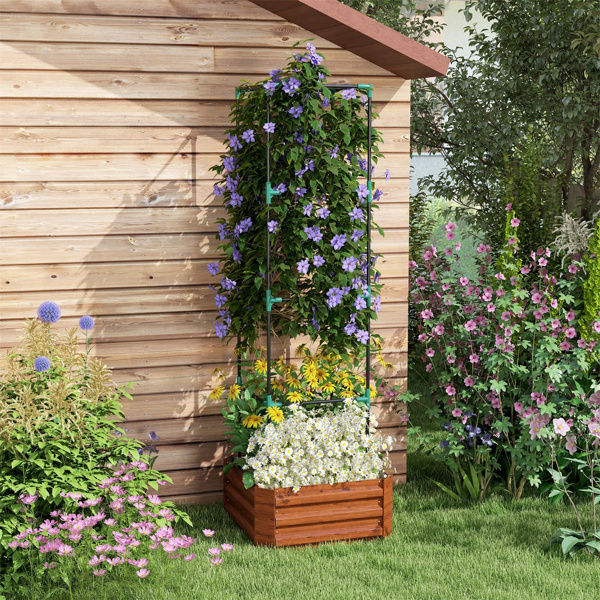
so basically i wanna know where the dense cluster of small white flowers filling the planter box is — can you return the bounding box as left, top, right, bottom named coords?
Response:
left=244, top=400, right=394, bottom=491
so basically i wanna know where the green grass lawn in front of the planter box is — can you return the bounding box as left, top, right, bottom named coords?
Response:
left=16, top=366, right=600, bottom=600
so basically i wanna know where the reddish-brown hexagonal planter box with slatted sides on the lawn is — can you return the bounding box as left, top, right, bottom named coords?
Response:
left=223, top=461, right=393, bottom=546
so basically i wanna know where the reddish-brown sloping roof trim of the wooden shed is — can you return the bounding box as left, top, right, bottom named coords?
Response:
left=246, top=0, right=450, bottom=79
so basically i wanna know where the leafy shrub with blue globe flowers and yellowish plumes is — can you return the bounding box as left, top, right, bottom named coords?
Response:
left=0, top=302, right=170, bottom=580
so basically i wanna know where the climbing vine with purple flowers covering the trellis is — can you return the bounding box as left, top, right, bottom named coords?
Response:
left=208, top=44, right=383, bottom=358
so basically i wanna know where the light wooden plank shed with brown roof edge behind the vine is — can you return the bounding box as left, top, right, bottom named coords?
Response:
left=0, top=0, right=448, bottom=503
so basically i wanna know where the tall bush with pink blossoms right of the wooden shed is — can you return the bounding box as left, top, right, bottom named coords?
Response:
left=404, top=206, right=600, bottom=499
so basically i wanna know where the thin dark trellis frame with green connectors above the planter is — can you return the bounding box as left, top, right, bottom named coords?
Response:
left=235, top=83, right=373, bottom=407
